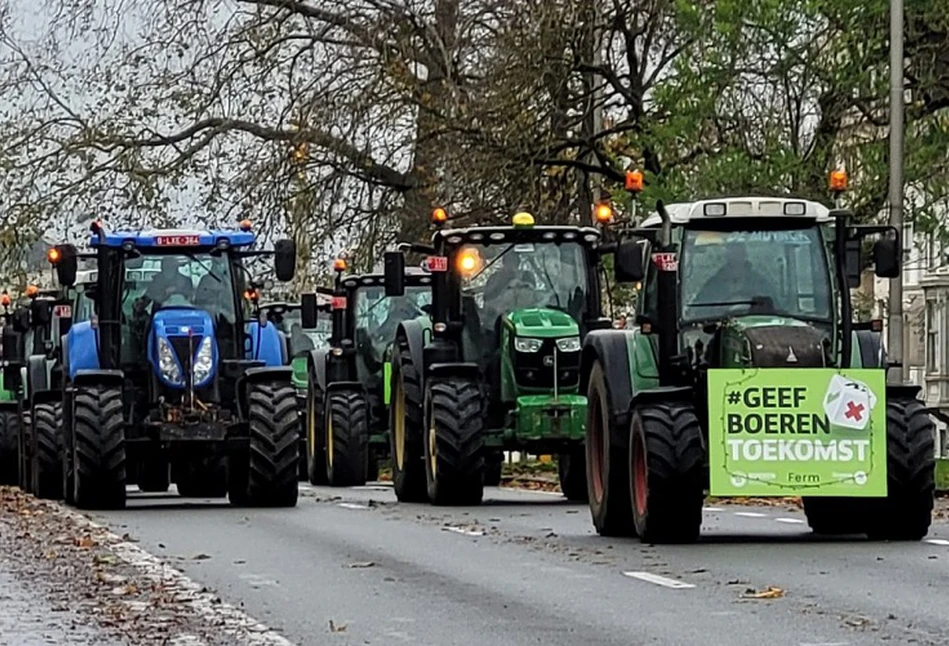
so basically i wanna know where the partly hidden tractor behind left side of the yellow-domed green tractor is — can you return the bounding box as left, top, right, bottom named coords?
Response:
left=303, top=261, right=432, bottom=486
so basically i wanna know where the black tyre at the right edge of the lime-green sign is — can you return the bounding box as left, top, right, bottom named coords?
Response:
left=866, top=396, right=936, bottom=541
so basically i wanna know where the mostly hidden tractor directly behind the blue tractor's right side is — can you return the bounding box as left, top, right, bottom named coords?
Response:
left=260, top=302, right=332, bottom=480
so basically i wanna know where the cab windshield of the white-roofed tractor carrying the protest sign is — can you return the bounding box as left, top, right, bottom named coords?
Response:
left=679, top=227, right=831, bottom=323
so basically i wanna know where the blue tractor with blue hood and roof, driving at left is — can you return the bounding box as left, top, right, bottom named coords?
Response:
left=49, top=221, right=299, bottom=509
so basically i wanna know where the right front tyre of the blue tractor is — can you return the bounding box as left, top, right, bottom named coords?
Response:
left=247, top=383, right=300, bottom=507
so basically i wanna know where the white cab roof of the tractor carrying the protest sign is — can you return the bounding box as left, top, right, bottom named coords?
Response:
left=641, top=197, right=833, bottom=227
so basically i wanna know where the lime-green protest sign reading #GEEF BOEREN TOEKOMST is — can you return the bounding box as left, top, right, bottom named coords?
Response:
left=708, top=368, right=886, bottom=497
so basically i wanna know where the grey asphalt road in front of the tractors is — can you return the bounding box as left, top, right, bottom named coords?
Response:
left=87, top=485, right=949, bottom=646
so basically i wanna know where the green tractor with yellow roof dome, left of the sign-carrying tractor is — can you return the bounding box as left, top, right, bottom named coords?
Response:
left=385, top=211, right=610, bottom=504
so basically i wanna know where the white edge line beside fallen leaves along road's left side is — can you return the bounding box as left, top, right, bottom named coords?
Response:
left=50, top=503, right=296, bottom=646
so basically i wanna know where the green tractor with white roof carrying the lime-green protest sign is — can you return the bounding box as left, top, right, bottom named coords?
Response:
left=582, top=191, right=934, bottom=542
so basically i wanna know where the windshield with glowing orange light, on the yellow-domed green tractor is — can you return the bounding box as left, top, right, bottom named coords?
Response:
left=455, top=242, right=587, bottom=330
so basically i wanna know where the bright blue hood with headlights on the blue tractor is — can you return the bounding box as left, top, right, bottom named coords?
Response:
left=148, top=307, right=218, bottom=389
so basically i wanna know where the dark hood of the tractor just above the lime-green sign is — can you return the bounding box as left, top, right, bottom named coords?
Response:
left=719, top=315, right=825, bottom=368
